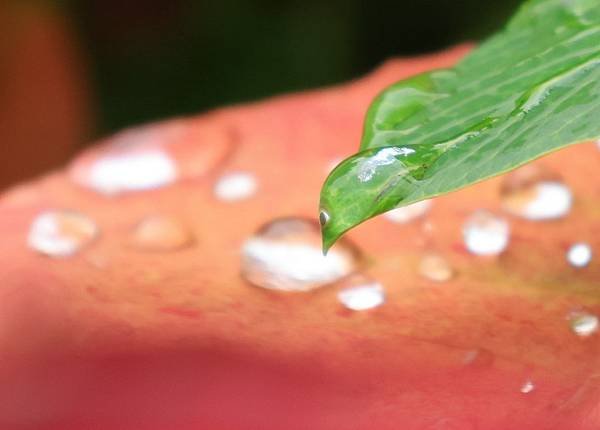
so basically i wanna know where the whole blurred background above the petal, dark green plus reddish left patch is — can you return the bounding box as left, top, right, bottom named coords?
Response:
left=0, top=0, right=519, bottom=189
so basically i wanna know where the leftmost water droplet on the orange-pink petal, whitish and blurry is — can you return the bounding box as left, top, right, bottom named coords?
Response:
left=27, top=211, right=98, bottom=257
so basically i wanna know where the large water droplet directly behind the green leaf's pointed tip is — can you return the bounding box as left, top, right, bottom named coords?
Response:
left=242, top=218, right=358, bottom=291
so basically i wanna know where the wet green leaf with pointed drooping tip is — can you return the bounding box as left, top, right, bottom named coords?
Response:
left=320, top=0, right=600, bottom=250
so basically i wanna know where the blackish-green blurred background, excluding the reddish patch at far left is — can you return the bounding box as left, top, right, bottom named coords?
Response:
left=63, top=0, right=519, bottom=134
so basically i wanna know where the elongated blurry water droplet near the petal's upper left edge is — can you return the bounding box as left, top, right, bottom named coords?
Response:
left=69, top=120, right=230, bottom=195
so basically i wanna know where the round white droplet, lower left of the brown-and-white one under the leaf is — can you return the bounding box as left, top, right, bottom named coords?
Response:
left=463, top=210, right=510, bottom=255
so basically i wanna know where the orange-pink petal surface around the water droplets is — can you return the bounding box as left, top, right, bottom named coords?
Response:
left=0, top=47, right=600, bottom=430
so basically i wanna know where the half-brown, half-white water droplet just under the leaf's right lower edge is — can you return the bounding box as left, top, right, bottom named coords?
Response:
left=502, top=165, right=573, bottom=221
